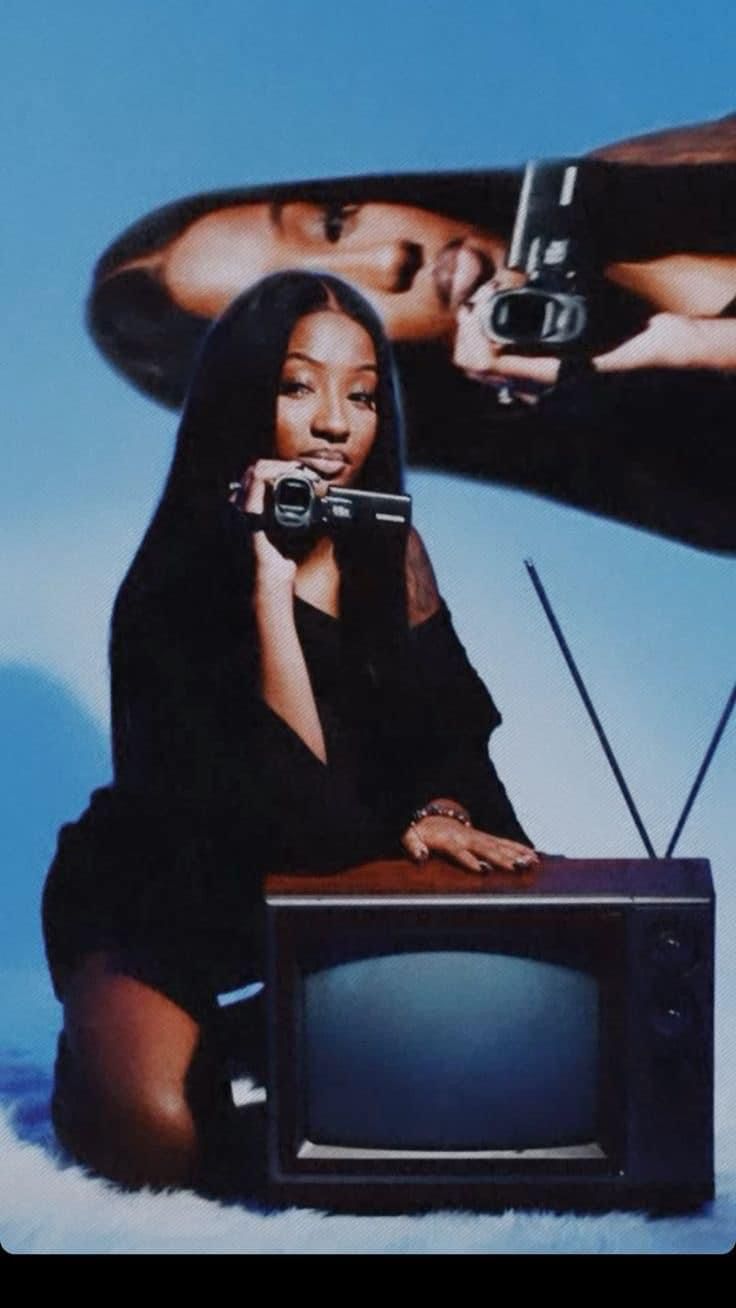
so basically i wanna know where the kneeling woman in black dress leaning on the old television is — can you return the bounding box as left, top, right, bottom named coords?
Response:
left=44, top=273, right=537, bottom=1185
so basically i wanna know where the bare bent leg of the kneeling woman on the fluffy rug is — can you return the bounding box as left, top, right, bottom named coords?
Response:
left=55, top=954, right=221, bottom=1186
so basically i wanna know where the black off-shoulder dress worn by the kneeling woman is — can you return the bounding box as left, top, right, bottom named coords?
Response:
left=43, top=600, right=528, bottom=1016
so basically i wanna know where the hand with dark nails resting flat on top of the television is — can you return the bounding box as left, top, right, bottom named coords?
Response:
left=401, top=816, right=539, bottom=874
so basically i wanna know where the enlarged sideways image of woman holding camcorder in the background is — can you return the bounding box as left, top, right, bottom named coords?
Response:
left=89, top=116, right=736, bottom=552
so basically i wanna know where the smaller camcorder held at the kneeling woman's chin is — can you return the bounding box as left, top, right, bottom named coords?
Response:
left=267, top=472, right=412, bottom=531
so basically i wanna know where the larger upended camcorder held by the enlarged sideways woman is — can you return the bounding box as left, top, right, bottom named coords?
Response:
left=484, top=160, right=650, bottom=357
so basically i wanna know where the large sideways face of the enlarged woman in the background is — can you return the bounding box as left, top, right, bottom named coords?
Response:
left=162, top=201, right=505, bottom=340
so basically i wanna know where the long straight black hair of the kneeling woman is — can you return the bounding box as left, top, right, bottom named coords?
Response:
left=110, top=272, right=408, bottom=765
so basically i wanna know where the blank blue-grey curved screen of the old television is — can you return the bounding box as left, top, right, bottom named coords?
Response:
left=303, top=948, right=600, bottom=1151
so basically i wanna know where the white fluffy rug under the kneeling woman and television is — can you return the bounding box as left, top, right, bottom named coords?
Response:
left=0, top=1050, right=736, bottom=1254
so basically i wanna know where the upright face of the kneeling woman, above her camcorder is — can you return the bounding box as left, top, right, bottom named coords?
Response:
left=275, top=309, right=378, bottom=487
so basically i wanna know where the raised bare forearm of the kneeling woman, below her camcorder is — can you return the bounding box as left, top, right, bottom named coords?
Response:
left=254, top=581, right=327, bottom=763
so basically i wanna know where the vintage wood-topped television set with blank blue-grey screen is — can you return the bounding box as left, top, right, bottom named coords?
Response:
left=265, top=858, right=714, bottom=1210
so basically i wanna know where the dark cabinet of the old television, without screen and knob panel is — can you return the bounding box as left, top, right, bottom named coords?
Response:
left=267, top=861, right=712, bottom=1209
